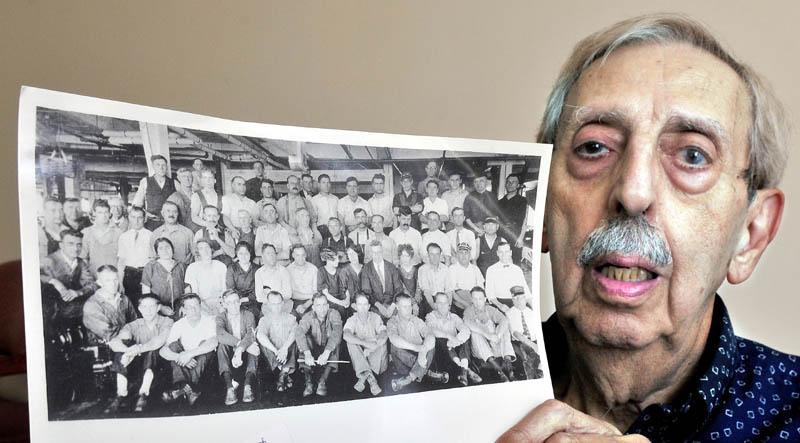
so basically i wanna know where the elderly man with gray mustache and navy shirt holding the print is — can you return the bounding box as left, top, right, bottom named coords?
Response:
left=501, top=15, right=800, bottom=441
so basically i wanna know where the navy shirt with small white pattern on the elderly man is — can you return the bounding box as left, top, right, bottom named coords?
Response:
left=543, top=296, right=800, bottom=442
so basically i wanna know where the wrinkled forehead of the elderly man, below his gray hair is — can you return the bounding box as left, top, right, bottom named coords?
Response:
left=558, top=43, right=752, bottom=160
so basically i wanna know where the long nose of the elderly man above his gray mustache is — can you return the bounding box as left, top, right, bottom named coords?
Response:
left=609, top=137, right=659, bottom=219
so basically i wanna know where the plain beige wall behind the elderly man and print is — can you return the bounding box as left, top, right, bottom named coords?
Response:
left=0, top=0, right=800, bottom=353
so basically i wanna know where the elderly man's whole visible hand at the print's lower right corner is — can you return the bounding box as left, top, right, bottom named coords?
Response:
left=497, top=400, right=649, bottom=443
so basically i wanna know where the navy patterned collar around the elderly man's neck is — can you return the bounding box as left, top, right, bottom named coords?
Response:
left=542, top=295, right=739, bottom=432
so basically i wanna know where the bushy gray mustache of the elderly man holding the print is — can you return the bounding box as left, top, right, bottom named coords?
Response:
left=578, top=215, right=672, bottom=268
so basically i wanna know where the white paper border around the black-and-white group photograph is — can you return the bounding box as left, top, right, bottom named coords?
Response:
left=18, top=87, right=553, bottom=443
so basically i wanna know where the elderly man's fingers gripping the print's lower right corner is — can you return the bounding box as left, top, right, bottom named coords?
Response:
left=497, top=400, right=621, bottom=443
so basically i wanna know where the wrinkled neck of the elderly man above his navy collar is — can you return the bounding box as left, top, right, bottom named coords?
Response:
left=553, top=300, right=713, bottom=431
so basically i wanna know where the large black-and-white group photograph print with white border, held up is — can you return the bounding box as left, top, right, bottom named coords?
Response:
left=20, top=89, right=552, bottom=441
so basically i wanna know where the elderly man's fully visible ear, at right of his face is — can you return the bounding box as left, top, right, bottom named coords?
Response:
left=728, top=189, right=785, bottom=285
